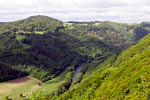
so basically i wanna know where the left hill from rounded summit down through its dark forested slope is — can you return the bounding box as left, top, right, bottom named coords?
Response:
left=0, top=16, right=117, bottom=81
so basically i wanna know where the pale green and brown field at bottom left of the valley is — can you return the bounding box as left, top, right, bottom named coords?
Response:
left=0, top=76, right=40, bottom=100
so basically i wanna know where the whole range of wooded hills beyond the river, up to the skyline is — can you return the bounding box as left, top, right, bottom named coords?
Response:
left=0, top=15, right=150, bottom=81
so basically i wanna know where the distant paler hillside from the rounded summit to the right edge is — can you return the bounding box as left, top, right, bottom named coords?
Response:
left=64, top=22, right=150, bottom=48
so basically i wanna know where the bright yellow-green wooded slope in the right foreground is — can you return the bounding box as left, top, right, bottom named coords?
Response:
left=58, top=35, right=150, bottom=100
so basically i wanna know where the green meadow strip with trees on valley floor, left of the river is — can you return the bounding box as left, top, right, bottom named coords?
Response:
left=32, top=66, right=74, bottom=100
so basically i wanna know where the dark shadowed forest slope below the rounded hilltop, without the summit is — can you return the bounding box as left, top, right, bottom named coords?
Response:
left=0, top=32, right=113, bottom=81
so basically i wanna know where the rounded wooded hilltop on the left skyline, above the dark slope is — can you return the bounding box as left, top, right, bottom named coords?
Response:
left=0, top=15, right=62, bottom=33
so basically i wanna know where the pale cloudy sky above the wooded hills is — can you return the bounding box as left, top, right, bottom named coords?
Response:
left=0, top=0, right=150, bottom=23
